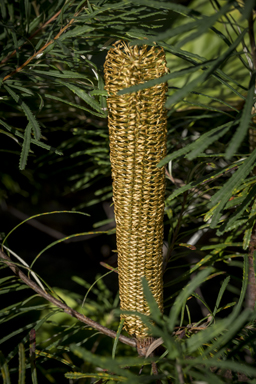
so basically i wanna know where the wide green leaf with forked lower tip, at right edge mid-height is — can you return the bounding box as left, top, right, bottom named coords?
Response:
left=209, top=149, right=256, bottom=228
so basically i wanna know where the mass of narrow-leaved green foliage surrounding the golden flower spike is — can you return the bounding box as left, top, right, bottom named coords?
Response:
left=0, top=0, right=256, bottom=384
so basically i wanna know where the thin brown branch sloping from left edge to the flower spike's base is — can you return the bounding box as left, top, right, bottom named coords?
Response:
left=0, top=249, right=136, bottom=348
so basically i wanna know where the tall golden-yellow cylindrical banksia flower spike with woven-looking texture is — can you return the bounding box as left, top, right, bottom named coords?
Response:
left=104, top=41, right=168, bottom=339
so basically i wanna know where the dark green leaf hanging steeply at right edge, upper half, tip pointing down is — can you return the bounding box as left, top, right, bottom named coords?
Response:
left=226, top=74, right=256, bottom=160
